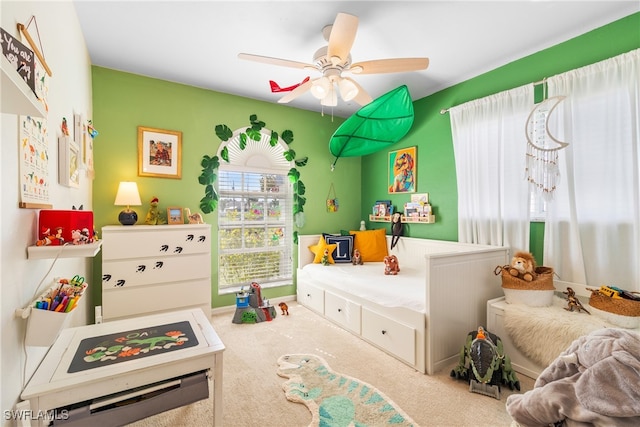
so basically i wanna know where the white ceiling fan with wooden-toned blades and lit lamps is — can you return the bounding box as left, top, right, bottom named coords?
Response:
left=238, top=13, right=429, bottom=107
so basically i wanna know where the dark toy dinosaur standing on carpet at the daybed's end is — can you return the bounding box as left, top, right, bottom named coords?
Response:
left=451, top=326, right=520, bottom=399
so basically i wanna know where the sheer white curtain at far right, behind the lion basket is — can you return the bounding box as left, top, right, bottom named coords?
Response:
left=544, top=50, right=640, bottom=290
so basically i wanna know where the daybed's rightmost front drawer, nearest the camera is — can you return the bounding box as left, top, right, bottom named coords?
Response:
left=362, top=307, right=416, bottom=365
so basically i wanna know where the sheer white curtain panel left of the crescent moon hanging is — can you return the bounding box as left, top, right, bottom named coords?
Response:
left=449, top=85, right=534, bottom=251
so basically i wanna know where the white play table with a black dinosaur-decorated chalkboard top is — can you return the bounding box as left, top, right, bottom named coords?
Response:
left=21, top=308, right=225, bottom=426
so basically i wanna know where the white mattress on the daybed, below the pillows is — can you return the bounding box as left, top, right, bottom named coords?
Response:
left=301, top=262, right=426, bottom=313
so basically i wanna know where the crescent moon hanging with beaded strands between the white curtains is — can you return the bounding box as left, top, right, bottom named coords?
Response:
left=525, top=96, right=569, bottom=201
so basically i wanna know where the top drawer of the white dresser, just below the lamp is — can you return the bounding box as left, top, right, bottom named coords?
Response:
left=102, top=225, right=211, bottom=260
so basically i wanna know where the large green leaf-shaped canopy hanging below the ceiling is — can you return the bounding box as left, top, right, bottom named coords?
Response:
left=329, top=85, right=413, bottom=169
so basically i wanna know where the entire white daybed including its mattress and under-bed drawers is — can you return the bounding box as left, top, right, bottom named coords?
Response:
left=297, top=235, right=509, bottom=374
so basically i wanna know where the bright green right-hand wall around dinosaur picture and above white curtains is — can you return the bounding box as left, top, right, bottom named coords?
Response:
left=362, top=13, right=640, bottom=263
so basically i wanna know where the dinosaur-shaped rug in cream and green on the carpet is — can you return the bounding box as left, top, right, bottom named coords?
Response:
left=278, top=354, right=416, bottom=427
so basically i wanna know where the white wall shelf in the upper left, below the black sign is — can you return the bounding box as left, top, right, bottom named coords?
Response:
left=0, top=54, right=47, bottom=117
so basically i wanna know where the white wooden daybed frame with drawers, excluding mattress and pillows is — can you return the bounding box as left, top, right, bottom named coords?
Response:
left=296, top=234, right=509, bottom=375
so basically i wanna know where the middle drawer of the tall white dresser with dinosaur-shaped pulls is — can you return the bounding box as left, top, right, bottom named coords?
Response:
left=102, top=254, right=211, bottom=289
